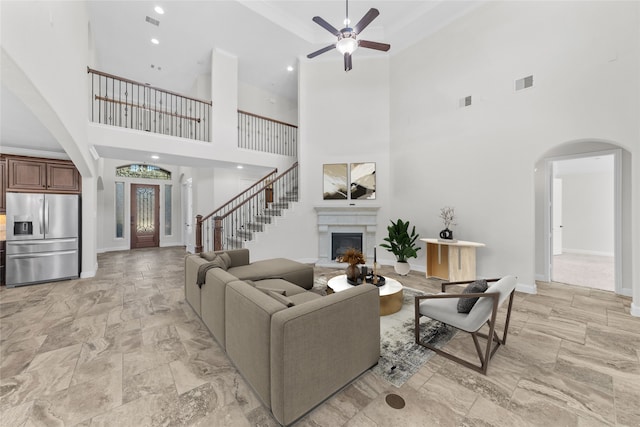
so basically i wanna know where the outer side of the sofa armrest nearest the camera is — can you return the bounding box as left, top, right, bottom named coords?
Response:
left=271, top=284, right=380, bottom=425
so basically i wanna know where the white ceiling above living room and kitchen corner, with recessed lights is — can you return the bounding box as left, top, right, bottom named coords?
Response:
left=0, top=0, right=486, bottom=160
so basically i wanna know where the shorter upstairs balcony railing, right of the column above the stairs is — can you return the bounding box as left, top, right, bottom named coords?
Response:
left=238, top=110, right=298, bottom=157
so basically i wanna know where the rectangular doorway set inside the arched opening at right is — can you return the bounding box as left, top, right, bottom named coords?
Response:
left=550, top=153, right=619, bottom=291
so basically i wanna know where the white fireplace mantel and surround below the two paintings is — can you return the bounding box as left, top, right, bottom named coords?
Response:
left=314, top=206, right=380, bottom=266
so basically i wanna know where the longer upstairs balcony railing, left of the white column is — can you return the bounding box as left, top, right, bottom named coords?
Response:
left=87, top=67, right=212, bottom=141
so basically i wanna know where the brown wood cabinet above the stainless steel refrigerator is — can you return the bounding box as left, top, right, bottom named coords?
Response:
left=7, top=157, right=81, bottom=194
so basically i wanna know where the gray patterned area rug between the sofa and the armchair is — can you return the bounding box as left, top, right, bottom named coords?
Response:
left=372, top=287, right=456, bottom=387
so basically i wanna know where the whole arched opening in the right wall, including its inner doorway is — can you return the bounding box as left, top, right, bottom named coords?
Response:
left=535, top=141, right=632, bottom=296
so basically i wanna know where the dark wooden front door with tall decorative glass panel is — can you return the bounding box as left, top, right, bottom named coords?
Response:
left=131, top=184, right=160, bottom=249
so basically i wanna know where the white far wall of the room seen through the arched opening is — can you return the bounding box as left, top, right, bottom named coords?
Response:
left=558, top=171, right=614, bottom=256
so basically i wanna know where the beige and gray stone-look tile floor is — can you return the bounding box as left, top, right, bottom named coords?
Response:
left=0, top=248, right=640, bottom=427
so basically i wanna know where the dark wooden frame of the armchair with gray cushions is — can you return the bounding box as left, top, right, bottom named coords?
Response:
left=415, top=279, right=515, bottom=375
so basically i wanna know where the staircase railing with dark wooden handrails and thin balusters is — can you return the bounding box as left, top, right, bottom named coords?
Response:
left=195, top=162, right=298, bottom=253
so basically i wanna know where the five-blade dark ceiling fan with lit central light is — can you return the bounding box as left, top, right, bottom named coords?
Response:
left=307, top=0, right=391, bottom=71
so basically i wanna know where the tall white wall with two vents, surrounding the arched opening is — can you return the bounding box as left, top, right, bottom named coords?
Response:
left=391, top=2, right=640, bottom=294
